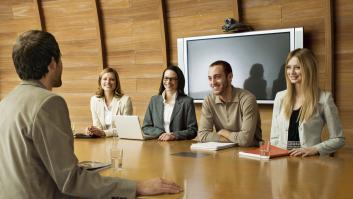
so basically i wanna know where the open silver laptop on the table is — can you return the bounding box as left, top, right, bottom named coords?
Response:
left=113, top=115, right=153, bottom=140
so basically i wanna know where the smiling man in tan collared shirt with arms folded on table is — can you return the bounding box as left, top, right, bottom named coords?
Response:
left=198, top=60, right=262, bottom=146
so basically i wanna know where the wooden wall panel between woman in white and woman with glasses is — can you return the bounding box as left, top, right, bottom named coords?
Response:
left=101, top=0, right=166, bottom=118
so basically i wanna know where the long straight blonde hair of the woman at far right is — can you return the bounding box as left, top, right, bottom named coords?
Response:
left=283, top=48, right=320, bottom=123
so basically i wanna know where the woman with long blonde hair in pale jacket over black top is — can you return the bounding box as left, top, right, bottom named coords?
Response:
left=271, top=48, right=344, bottom=156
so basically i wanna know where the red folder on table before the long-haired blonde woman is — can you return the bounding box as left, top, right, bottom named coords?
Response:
left=239, top=145, right=289, bottom=159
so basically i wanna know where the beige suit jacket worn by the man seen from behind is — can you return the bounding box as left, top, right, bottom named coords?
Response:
left=0, top=81, right=136, bottom=198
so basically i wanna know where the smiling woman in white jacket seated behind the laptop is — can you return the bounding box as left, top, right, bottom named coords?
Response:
left=88, top=68, right=132, bottom=137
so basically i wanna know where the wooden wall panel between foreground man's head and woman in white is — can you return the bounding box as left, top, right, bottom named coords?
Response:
left=42, top=0, right=103, bottom=128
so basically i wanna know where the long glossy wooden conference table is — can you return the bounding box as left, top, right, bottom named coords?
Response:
left=74, top=138, right=353, bottom=199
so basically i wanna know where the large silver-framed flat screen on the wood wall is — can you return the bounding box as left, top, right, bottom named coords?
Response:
left=177, top=27, right=303, bottom=104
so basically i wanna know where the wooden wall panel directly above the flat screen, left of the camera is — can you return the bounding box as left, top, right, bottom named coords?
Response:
left=166, top=0, right=235, bottom=65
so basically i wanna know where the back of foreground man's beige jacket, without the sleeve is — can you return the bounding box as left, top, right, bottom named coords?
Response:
left=0, top=80, right=73, bottom=198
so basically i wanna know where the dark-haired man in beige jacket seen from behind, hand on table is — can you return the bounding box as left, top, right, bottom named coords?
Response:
left=0, top=30, right=181, bottom=198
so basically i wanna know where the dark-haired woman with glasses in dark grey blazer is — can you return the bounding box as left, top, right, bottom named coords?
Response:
left=142, top=66, right=197, bottom=141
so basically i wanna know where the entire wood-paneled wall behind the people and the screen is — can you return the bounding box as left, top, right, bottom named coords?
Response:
left=0, top=0, right=353, bottom=144
